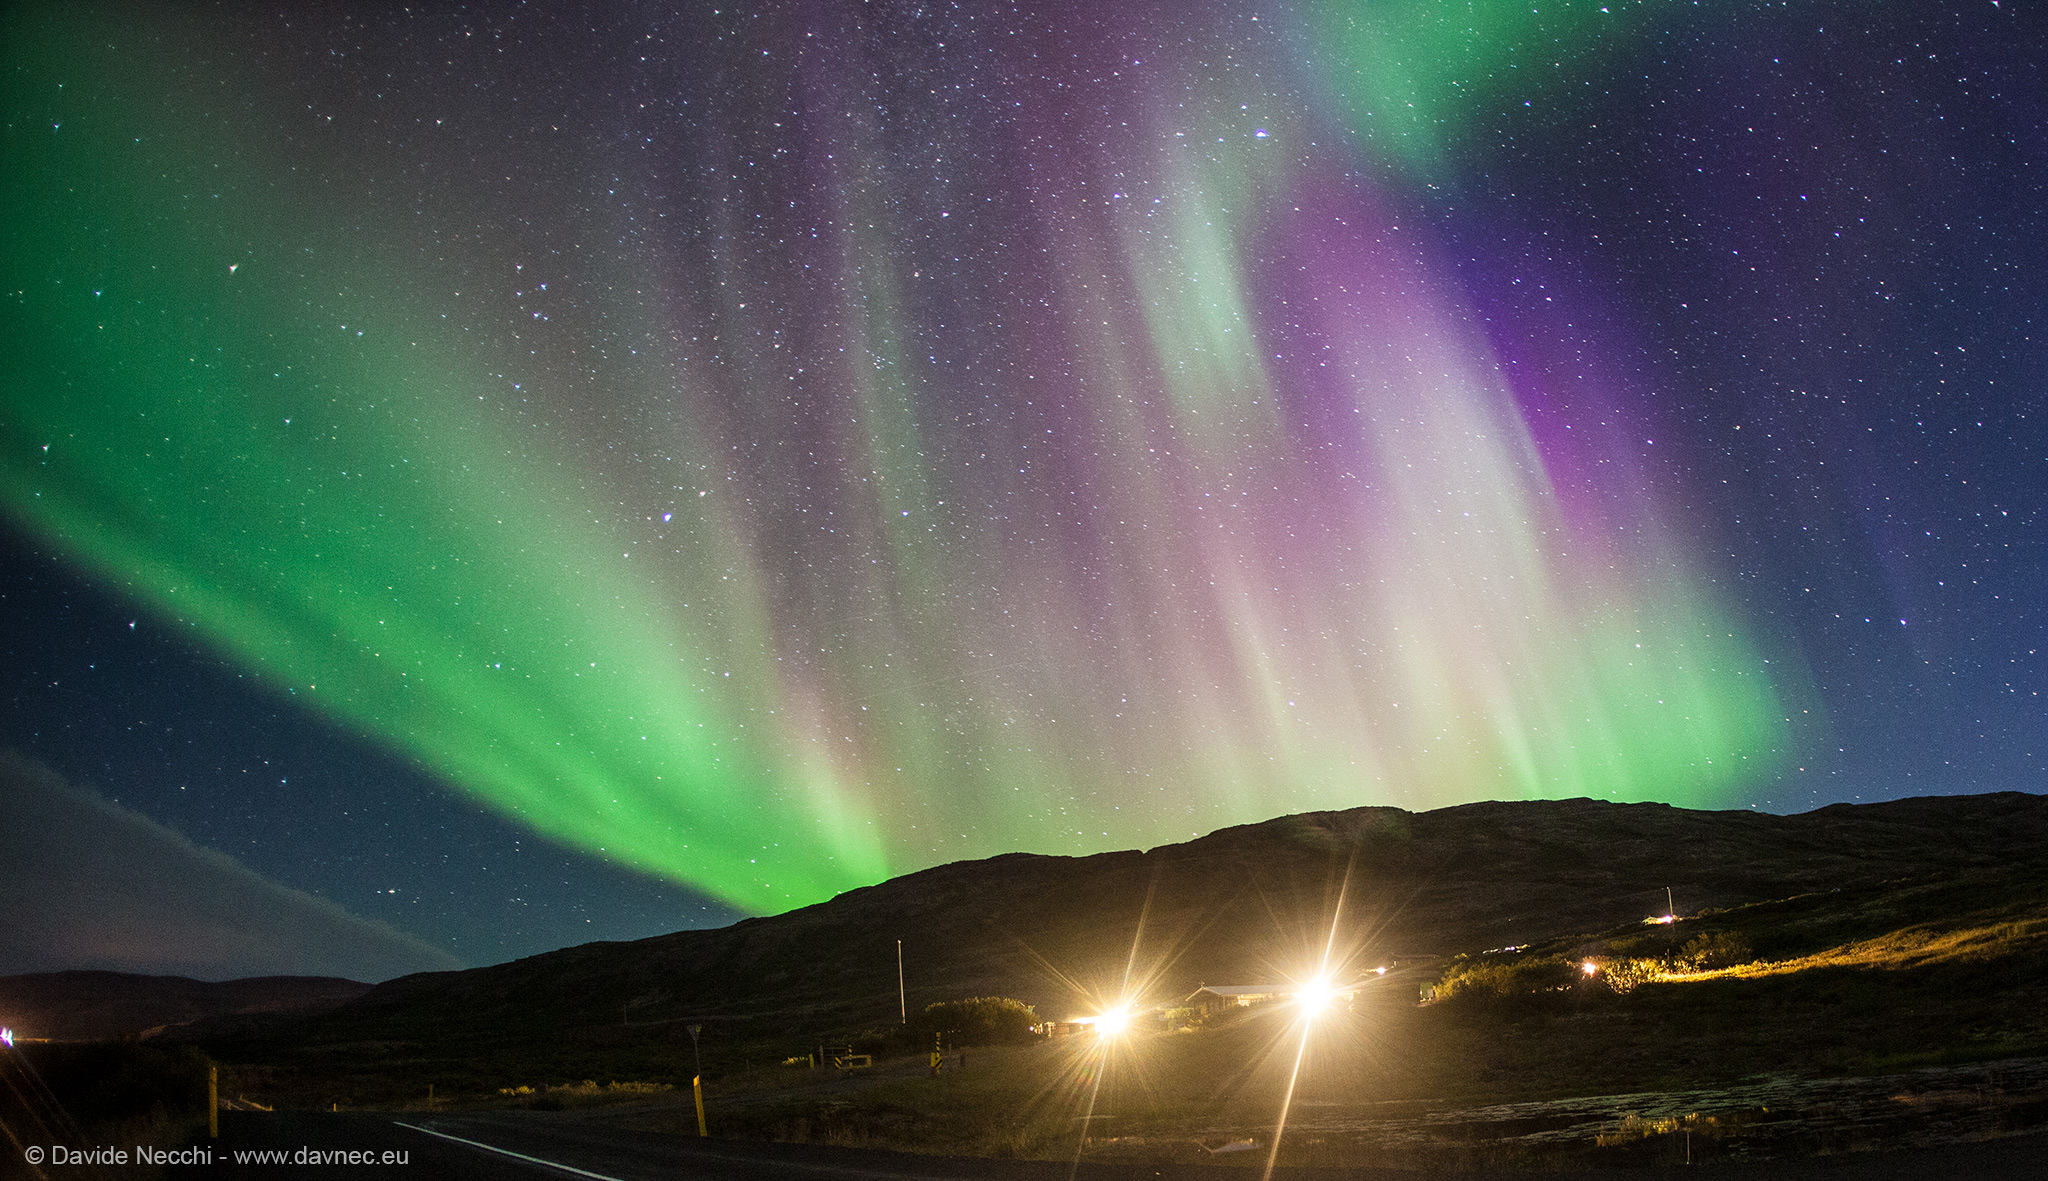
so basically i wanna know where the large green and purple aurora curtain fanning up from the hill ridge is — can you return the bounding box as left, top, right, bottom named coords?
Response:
left=0, top=4, right=1786, bottom=911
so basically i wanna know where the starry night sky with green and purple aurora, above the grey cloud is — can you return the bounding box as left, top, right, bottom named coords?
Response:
left=0, top=0, right=2048, bottom=974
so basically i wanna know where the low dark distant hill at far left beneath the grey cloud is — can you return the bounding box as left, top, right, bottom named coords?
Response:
left=0, top=972, right=371, bottom=1042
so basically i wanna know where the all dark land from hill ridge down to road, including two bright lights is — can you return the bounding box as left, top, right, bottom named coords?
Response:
left=4, top=792, right=2048, bottom=1175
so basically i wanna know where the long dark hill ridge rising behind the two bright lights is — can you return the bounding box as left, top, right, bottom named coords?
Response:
left=221, top=792, right=2048, bottom=1070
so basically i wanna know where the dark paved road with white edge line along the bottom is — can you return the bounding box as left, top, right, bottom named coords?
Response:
left=148, top=1111, right=2048, bottom=1181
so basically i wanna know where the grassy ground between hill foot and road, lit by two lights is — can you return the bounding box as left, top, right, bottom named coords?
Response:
left=195, top=843, right=2048, bottom=1169
